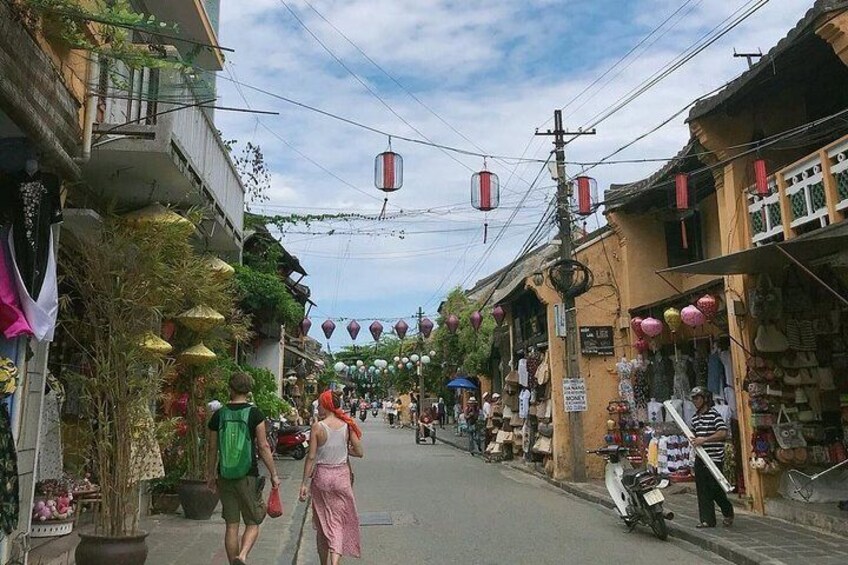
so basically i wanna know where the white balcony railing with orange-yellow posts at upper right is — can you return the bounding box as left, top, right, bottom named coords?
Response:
left=748, top=136, right=848, bottom=245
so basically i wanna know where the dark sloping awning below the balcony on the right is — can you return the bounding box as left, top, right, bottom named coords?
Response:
left=658, top=222, right=848, bottom=275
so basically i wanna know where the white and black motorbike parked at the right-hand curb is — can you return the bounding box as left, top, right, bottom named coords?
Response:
left=587, top=445, right=674, bottom=540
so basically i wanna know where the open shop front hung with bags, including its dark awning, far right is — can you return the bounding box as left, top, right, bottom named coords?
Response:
left=673, top=221, right=848, bottom=519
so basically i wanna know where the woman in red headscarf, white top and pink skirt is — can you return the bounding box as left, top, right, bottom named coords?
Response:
left=300, top=391, right=363, bottom=565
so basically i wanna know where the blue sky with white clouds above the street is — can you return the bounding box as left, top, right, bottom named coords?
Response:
left=216, top=0, right=813, bottom=348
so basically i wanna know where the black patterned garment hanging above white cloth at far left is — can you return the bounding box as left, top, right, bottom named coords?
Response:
left=0, top=171, right=62, bottom=299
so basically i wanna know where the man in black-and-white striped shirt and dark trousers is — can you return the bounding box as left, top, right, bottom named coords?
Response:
left=690, top=386, right=733, bottom=528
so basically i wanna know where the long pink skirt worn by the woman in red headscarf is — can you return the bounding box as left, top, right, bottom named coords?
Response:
left=312, top=463, right=360, bottom=557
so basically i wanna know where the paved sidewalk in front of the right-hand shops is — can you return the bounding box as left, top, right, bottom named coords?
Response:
left=436, top=434, right=848, bottom=565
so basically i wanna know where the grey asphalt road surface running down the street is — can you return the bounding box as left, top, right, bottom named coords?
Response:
left=298, top=419, right=726, bottom=565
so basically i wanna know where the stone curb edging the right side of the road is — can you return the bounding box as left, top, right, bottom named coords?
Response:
left=436, top=435, right=760, bottom=565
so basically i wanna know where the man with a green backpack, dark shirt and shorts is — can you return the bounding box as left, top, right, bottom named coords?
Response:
left=206, top=371, right=280, bottom=565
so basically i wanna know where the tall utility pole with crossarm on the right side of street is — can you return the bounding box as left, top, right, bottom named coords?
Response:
left=536, top=110, right=595, bottom=481
